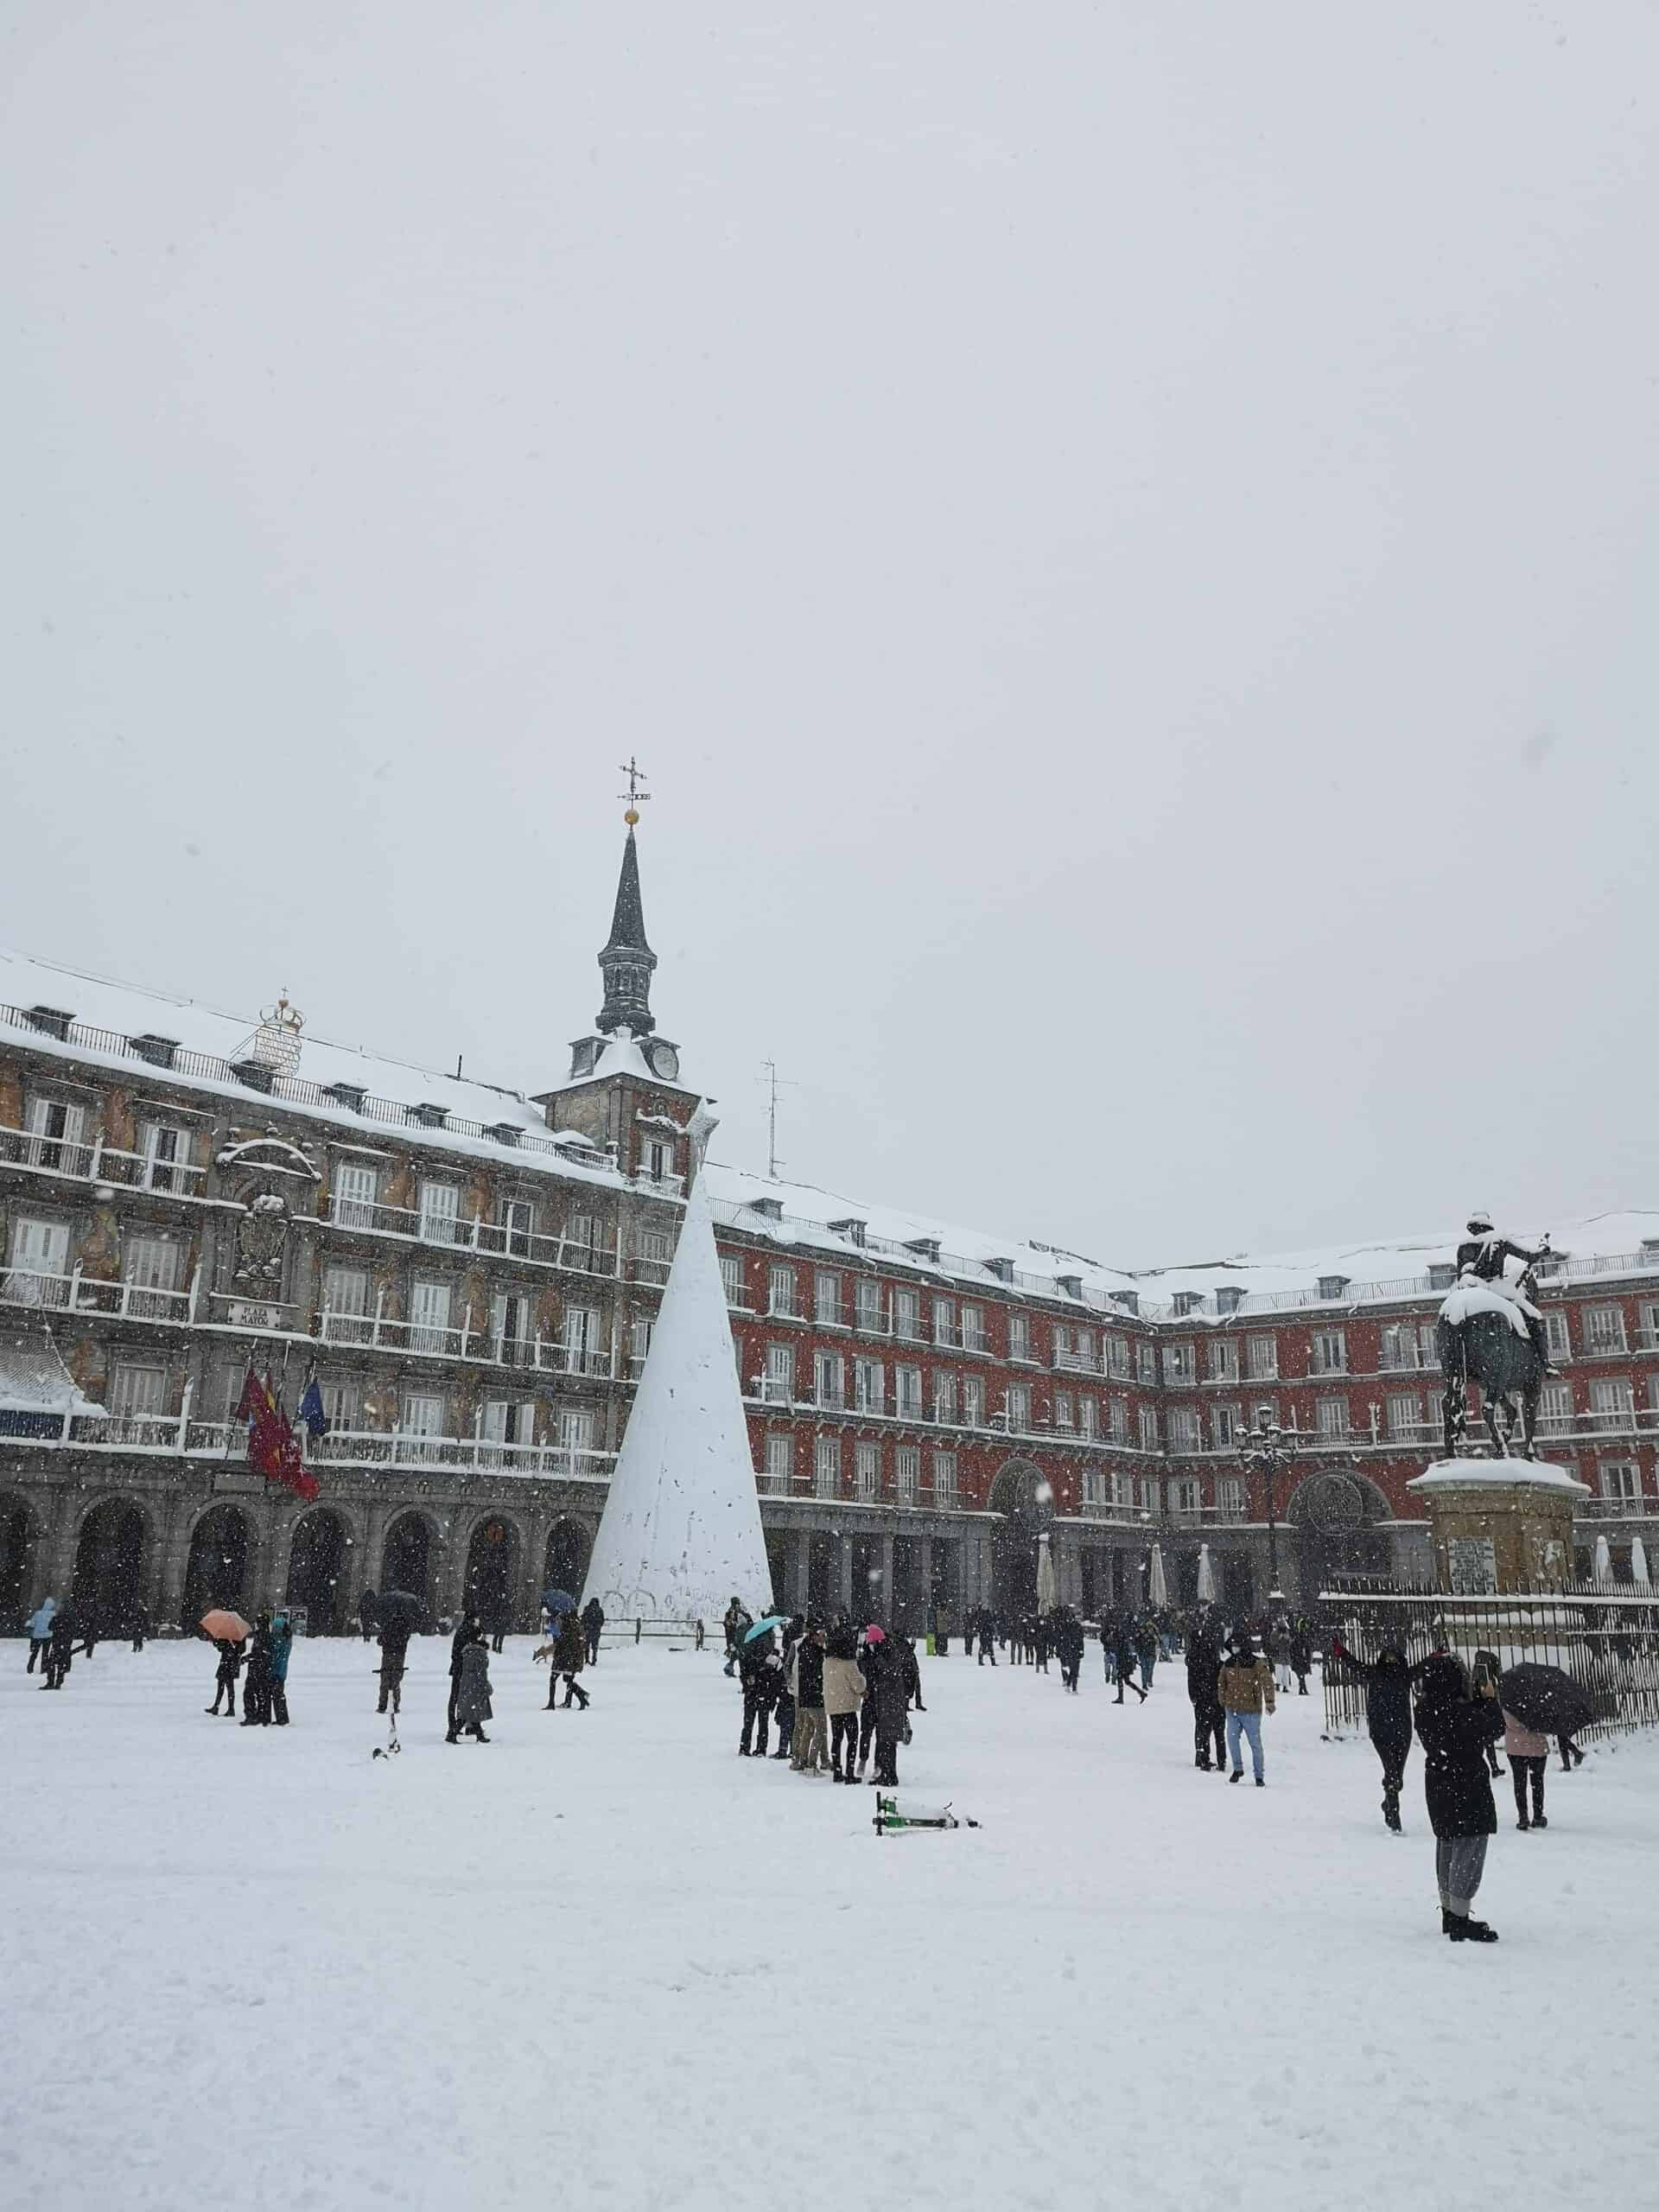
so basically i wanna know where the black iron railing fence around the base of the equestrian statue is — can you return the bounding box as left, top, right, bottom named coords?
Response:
left=1319, top=1575, right=1659, bottom=1737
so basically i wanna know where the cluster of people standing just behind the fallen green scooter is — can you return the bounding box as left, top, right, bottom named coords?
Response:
left=723, top=1599, right=927, bottom=1787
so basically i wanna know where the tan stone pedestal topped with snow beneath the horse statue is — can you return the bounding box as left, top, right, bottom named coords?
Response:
left=1407, top=1460, right=1591, bottom=1592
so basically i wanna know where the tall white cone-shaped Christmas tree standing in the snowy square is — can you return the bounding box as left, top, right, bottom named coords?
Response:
left=584, top=1174, right=772, bottom=1621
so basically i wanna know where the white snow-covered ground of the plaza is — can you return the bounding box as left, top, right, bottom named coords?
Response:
left=0, top=1639, right=1659, bottom=2212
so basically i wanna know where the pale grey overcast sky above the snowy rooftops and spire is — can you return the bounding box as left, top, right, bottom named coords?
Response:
left=0, top=0, right=1659, bottom=1265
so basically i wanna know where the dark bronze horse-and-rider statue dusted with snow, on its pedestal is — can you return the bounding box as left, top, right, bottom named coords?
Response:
left=1435, top=1214, right=1551, bottom=1460
